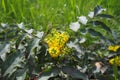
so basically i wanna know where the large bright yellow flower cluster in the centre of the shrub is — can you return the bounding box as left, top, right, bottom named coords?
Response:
left=45, top=29, right=69, bottom=57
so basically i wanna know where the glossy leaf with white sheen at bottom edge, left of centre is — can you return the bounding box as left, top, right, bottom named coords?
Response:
left=38, top=68, right=59, bottom=80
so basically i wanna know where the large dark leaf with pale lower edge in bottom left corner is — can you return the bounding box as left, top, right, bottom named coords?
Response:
left=2, top=51, right=23, bottom=76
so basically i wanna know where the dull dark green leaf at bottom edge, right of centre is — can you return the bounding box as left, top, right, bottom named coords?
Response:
left=62, top=66, right=88, bottom=80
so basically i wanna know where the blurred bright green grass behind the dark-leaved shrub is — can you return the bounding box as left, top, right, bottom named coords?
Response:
left=0, top=0, right=120, bottom=30
